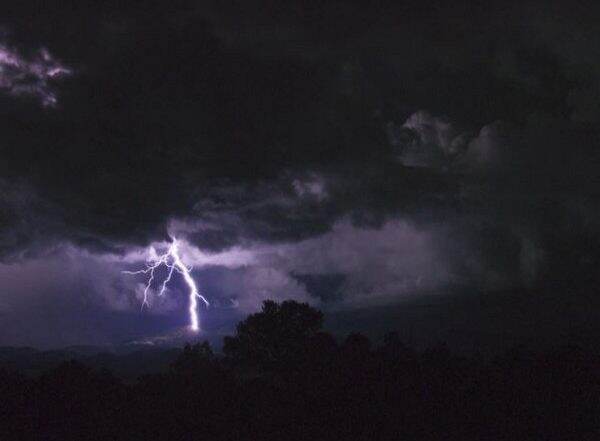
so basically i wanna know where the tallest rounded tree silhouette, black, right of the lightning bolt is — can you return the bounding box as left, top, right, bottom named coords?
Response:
left=223, top=300, right=323, bottom=368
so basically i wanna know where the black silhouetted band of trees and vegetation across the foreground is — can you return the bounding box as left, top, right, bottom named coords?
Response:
left=0, top=302, right=600, bottom=441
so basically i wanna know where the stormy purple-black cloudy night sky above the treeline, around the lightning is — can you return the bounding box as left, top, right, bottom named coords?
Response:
left=0, top=0, right=600, bottom=346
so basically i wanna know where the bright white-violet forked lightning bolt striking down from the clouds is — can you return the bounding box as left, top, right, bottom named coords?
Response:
left=123, top=238, right=210, bottom=332
